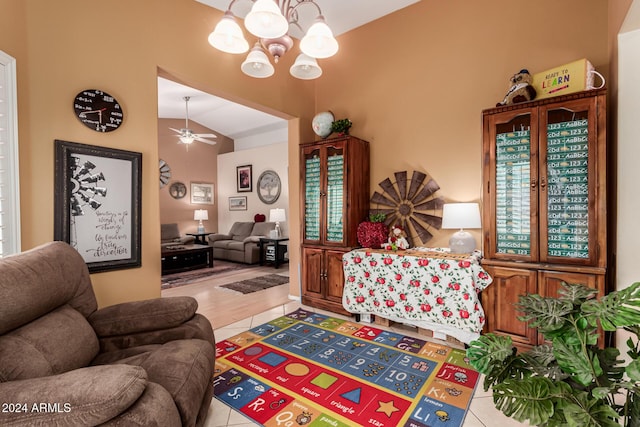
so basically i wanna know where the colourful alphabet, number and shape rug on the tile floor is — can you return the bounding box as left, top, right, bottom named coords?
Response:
left=214, top=309, right=479, bottom=427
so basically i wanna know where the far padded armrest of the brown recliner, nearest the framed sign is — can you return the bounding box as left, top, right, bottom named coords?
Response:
left=87, top=297, right=198, bottom=338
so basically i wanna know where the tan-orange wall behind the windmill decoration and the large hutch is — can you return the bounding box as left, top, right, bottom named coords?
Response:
left=316, top=0, right=609, bottom=246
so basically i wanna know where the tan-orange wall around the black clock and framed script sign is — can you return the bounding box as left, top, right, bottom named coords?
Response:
left=0, top=0, right=313, bottom=306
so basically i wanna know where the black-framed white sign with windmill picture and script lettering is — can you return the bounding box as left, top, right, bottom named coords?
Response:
left=54, top=140, right=142, bottom=273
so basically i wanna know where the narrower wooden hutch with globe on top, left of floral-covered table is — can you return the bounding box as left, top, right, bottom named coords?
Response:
left=300, top=135, right=369, bottom=314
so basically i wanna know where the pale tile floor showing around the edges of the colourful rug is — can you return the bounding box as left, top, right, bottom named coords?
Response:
left=205, top=302, right=528, bottom=427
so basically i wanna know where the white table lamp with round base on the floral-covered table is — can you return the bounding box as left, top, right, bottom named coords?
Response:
left=442, top=203, right=482, bottom=254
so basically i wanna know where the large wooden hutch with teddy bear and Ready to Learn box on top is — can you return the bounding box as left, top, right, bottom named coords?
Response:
left=482, top=89, right=607, bottom=349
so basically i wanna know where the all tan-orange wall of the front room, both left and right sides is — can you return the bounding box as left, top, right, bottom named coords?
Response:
left=0, top=0, right=628, bottom=305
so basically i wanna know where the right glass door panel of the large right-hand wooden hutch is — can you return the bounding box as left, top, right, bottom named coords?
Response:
left=546, top=108, right=589, bottom=258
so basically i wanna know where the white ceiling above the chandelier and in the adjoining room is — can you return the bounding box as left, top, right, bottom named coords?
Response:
left=158, top=0, right=420, bottom=139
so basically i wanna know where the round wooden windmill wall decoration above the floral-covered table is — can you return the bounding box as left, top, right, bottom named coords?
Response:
left=371, top=171, right=444, bottom=246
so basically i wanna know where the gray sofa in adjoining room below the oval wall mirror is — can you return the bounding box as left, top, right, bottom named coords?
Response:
left=209, top=222, right=276, bottom=264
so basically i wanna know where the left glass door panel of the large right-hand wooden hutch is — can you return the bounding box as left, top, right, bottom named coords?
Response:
left=495, top=115, right=531, bottom=256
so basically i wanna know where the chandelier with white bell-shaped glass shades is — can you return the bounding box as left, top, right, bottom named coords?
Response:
left=209, top=0, right=338, bottom=80
